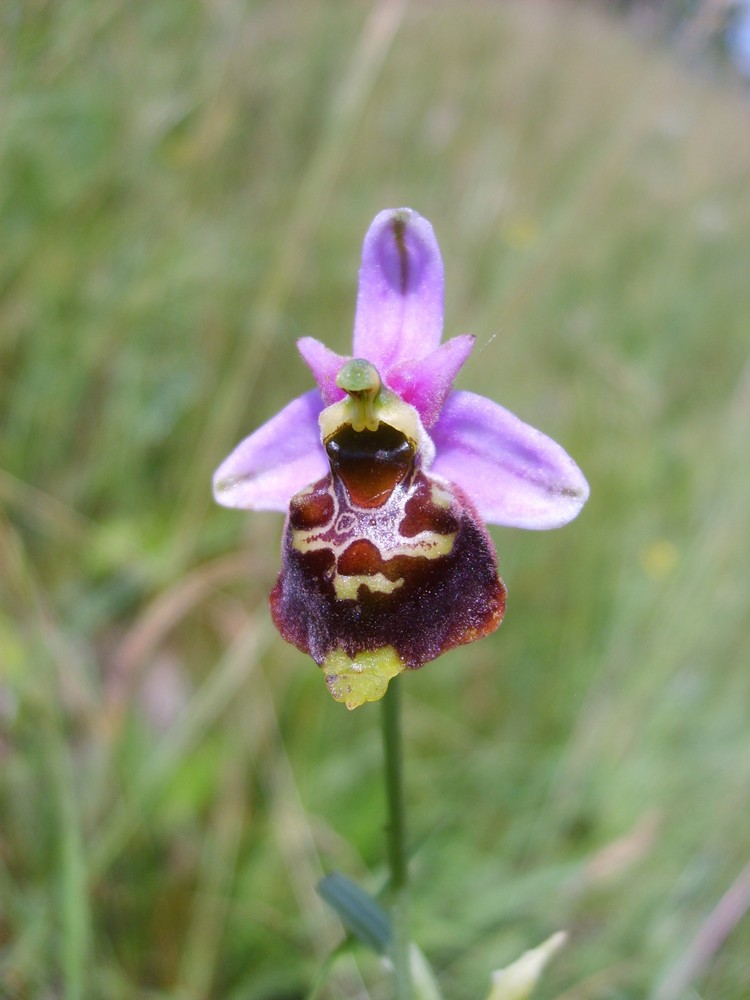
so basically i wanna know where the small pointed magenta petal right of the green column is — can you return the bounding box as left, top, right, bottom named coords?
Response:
left=388, top=334, right=476, bottom=427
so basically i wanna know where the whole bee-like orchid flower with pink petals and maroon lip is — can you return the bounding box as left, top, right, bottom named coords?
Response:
left=214, top=208, right=588, bottom=708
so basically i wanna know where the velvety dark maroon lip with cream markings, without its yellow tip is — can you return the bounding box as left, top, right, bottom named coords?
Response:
left=271, top=466, right=505, bottom=669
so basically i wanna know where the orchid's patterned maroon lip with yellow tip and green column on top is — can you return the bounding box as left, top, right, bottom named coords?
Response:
left=271, top=359, right=505, bottom=708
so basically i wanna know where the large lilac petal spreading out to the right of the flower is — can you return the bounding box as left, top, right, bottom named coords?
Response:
left=431, top=392, right=589, bottom=528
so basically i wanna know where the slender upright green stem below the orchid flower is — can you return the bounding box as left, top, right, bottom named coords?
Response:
left=382, top=677, right=412, bottom=1000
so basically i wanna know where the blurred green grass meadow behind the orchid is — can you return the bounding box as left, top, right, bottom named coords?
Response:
left=0, top=0, right=750, bottom=1000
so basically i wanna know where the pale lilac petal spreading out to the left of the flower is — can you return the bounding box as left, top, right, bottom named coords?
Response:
left=214, top=389, right=328, bottom=511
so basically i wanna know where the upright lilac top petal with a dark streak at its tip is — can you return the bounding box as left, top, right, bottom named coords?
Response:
left=353, top=208, right=444, bottom=372
